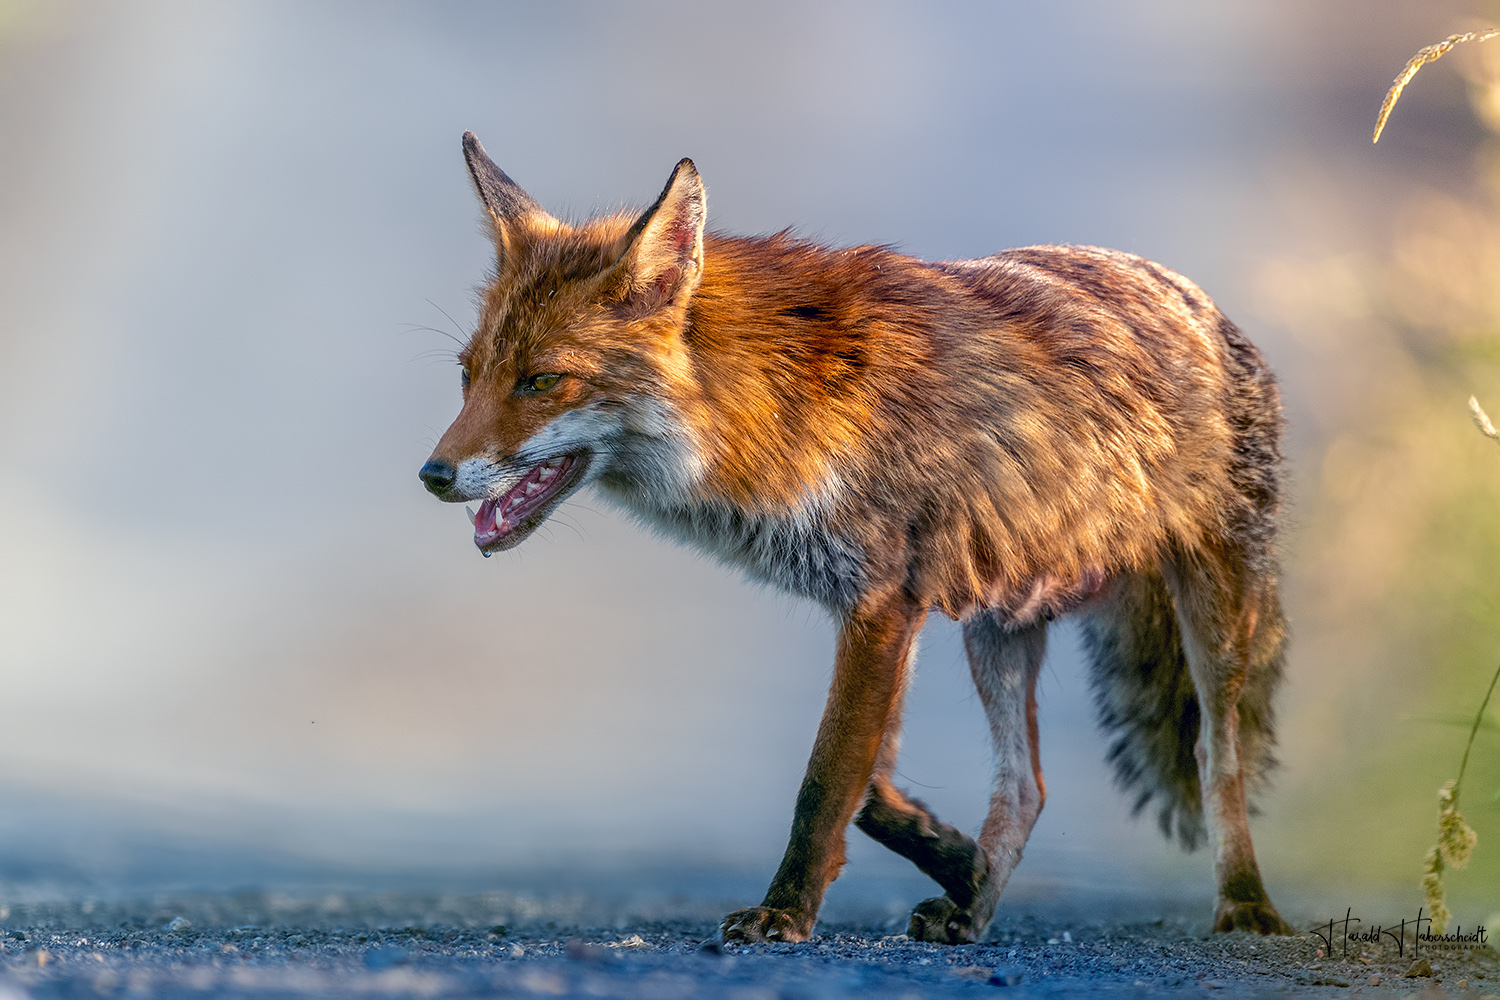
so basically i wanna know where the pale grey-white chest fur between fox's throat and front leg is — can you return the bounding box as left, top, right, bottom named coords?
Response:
left=641, top=504, right=866, bottom=609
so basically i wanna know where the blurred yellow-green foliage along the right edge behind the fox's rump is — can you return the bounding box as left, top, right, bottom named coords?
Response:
left=1260, top=56, right=1500, bottom=919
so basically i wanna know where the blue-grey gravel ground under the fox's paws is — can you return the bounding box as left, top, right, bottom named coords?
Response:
left=0, top=892, right=1500, bottom=1000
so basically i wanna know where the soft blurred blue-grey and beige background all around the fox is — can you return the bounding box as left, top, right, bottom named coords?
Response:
left=0, top=0, right=1500, bottom=924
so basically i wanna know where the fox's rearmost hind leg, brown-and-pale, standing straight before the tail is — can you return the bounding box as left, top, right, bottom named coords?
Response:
left=1167, top=552, right=1293, bottom=934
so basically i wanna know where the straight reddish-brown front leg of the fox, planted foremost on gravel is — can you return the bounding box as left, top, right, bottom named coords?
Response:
left=723, top=595, right=926, bottom=942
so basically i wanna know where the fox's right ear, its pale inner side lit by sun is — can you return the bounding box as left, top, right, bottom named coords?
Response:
left=623, top=159, right=708, bottom=306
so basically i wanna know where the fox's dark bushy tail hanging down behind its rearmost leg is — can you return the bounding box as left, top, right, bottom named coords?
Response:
left=1082, top=573, right=1281, bottom=850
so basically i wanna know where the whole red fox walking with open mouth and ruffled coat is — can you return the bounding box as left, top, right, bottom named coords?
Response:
left=420, top=132, right=1293, bottom=945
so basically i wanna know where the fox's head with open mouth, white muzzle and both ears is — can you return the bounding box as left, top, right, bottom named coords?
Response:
left=420, top=132, right=707, bottom=555
